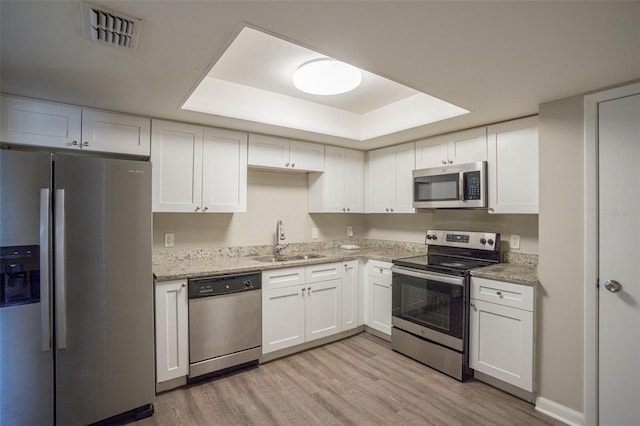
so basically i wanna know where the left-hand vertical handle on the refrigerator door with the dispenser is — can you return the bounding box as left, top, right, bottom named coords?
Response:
left=40, top=188, right=51, bottom=352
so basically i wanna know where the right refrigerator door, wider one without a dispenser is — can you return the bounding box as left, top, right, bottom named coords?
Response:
left=54, top=155, right=155, bottom=425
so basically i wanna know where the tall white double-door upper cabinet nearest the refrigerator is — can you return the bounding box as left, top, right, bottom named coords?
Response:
left=151, top=120, right=247, bottom=213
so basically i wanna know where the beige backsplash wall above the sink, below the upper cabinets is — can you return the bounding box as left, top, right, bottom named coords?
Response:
left=153, top=170, right=365, bottom=249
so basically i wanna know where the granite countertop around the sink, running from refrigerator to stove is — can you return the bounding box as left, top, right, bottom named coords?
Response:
left=153, top=247, right=419, bottom=281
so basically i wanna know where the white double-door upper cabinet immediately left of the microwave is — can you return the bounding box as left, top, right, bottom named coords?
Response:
left=367, top=143, right=415, bottom=213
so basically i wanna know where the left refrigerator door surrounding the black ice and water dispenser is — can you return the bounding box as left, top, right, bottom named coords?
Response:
left=0, top=150, right=53, bottom=426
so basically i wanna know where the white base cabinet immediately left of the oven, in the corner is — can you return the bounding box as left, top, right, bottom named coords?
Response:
left=365, top=260, right=392, bottom=336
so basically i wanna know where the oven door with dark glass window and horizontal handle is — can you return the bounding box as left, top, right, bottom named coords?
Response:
left=391, top=266, right=467, bottom=352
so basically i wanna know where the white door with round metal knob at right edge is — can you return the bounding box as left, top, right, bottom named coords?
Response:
left=598, top=95, right=640, bottom=425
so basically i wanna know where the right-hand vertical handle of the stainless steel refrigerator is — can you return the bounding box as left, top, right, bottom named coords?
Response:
left=55, top=189, right=67, bottom=349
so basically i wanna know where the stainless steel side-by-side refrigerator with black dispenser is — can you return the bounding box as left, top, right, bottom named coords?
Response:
left=0, top=150, right=155, bottom=426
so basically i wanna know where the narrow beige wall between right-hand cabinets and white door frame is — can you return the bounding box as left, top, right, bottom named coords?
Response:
left=538, top=96, right=584, bottom=412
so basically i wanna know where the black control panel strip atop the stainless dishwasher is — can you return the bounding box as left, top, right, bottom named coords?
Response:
left=189, top=271, right=262, bottom=299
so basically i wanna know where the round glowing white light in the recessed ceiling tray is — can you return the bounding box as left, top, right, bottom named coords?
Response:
left=293, top=58, right=362, bottom=95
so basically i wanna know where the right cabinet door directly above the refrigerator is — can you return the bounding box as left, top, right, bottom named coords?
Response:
left=82, top=109, right=151, bottom=157
